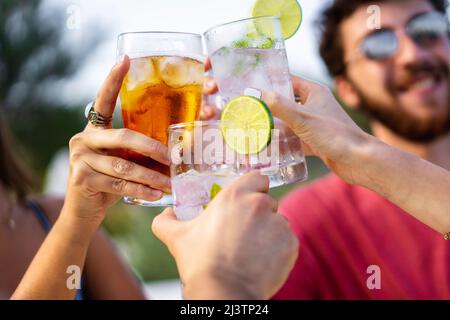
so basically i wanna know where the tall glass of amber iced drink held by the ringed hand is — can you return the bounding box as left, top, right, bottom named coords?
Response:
left=117, top=32, right=204, bottom=206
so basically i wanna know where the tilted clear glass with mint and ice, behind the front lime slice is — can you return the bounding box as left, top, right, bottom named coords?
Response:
left=204, top=17, right=308, bottom=187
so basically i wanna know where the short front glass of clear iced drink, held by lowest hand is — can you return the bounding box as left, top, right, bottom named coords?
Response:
left=169, top=121, right=244, bottom=220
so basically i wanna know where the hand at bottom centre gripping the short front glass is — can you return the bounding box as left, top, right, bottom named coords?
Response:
left=152, top=172, right=298, bottom=299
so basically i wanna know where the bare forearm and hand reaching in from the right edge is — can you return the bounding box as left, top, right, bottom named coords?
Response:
left=264, top=77, right=450, bottom=238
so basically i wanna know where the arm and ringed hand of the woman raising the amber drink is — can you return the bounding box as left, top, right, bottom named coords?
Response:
left=12, top=57, right=170, bottom=299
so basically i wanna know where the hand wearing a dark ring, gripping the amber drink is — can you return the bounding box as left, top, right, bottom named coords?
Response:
left=63, top=56, right=170, bottom=230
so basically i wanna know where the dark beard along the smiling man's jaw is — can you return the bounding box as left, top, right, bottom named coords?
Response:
left=355, top=86, right=450, bottom=143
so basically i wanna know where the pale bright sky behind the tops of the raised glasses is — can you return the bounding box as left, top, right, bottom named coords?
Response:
left=42, top=0, right=328, bottom=105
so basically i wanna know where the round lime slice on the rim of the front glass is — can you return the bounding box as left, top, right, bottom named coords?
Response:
left=220, top=96, right=273, bottom=155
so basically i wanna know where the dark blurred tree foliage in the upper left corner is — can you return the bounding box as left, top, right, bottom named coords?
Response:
left=0, top=0, right=100, bottom=180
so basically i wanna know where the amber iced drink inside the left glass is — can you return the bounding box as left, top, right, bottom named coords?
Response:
left=120, top=55, right=204, bottom=175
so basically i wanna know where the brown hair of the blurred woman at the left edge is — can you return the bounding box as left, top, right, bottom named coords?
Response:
left=0, top=110, right=36, bottom=201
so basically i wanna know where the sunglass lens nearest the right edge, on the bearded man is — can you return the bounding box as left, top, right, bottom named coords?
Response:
left=408, top=12, right=449, bottom=43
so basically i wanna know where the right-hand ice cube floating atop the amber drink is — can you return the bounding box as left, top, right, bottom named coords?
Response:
left=158, top=56, right=204, bottom=88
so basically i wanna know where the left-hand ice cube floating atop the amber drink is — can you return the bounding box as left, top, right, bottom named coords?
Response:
left=126, top=57, right=159, bottom=90
